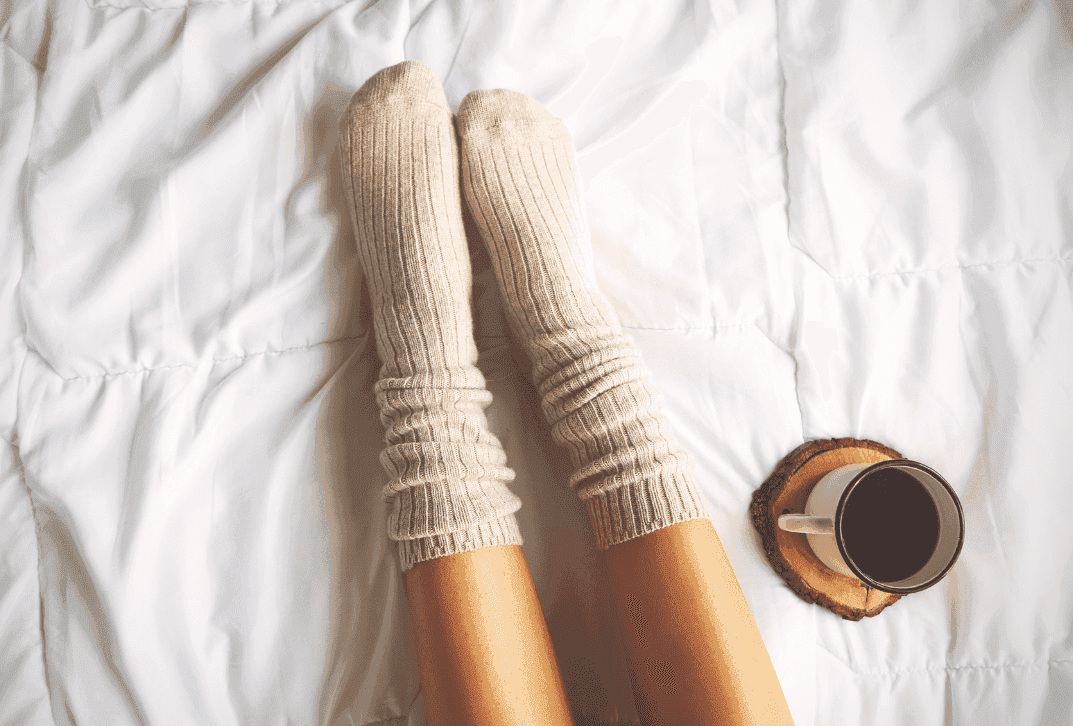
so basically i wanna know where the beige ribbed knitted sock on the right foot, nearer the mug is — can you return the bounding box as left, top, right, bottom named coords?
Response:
left=455, top=90, right=708, bottom=549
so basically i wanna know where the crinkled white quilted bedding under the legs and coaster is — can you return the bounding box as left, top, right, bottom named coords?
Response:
left=0, top=0, right=1073, bottom=726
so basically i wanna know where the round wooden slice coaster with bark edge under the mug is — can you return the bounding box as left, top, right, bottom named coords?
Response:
left=749, top=439, right=903, bottom=620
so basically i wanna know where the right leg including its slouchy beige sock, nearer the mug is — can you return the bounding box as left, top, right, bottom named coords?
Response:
left=456, top=90, right=792, bottom=726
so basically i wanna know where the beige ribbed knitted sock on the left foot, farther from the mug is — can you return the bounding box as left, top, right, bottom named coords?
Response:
left=341, top=61, right=523, bottom=572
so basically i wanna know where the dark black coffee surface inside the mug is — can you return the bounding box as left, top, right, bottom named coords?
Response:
left=842, top=468, right=939, bottom=582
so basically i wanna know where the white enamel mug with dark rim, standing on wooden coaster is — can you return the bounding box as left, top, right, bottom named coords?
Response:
left=779, top=459, right=965, bottom=594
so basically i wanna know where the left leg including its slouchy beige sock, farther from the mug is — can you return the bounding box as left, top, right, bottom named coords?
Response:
left=342, top=63, right=573, bottom=726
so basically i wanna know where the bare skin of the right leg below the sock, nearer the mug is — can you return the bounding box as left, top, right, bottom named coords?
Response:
left=605, top=519, right=793, bottom=726
